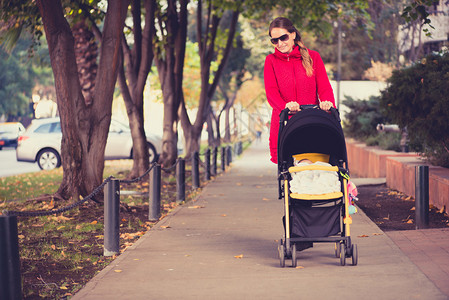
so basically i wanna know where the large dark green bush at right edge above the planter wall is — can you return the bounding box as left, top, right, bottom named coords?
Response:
left=380, top=53, right=449, bottom=167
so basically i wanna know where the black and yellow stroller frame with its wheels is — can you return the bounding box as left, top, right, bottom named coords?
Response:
left=278, top=105, right=358, bottom=267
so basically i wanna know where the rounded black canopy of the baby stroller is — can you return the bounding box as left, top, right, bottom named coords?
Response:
left=278, top=109, right=347, bottom=165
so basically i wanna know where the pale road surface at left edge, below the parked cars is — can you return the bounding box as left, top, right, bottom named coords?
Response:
left=0, top=147, right=40, bottom=177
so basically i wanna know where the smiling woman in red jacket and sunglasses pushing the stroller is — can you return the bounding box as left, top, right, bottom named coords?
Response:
left=264, top=17, right=335, bottom=163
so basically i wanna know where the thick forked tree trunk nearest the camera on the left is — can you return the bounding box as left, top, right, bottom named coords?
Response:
left=37, top=0, right=127, bottom=200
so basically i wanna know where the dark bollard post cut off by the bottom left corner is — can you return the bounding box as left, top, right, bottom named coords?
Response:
left=0, top=216, right=22, bottom=300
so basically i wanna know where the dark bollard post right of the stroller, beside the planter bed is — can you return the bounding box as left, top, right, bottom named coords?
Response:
left=415, top=166, right=429, bottom=229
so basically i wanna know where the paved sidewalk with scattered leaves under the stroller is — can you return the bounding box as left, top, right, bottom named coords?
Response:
left=72, top=143, right=449, bottom=300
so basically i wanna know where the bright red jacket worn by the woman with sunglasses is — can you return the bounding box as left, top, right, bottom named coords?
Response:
left=264, top=46, right=335, bottom=163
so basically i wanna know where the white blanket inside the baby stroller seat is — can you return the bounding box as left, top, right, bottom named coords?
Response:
left=290, top=161, right=341, bottom=195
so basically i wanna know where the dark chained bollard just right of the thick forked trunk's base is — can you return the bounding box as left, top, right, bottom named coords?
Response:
left=103, top=179, right=120, bottom=256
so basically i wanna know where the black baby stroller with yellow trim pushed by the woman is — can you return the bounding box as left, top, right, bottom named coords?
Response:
left=278, top=105, right=358, bottom=267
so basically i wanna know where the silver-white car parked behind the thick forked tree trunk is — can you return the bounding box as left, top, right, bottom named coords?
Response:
left=16, top=118, right=162, bottom=170
